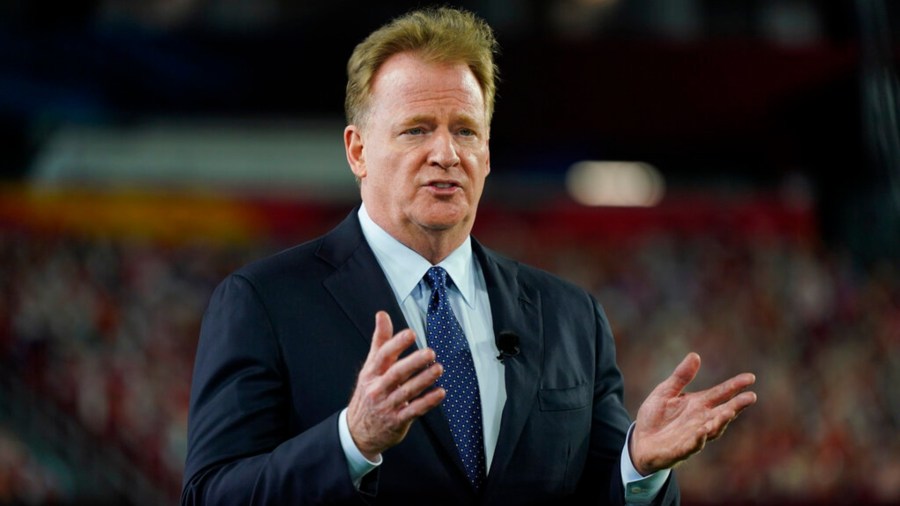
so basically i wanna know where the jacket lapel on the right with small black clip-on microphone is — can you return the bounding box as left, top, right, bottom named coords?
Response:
left=473, top=241, right=543, bottom=494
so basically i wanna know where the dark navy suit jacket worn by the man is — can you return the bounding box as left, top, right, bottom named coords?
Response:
left=182, top=208, right=678, bottom=505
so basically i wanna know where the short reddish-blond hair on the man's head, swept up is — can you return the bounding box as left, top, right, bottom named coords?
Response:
left=344, top=7, right=499, bottom=125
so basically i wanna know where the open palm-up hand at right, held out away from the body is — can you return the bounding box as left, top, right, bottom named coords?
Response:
left=629, top=353, right=756, bottom=476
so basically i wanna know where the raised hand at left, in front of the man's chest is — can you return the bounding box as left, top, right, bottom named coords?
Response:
left=347, top=311, right=446, bottom=460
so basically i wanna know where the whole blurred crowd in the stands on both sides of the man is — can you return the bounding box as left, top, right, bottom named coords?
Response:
left=0, top=204, right=900, bottom=504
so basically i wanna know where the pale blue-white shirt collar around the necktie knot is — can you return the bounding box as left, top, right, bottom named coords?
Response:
left=357, top=204, right=475, bottom=307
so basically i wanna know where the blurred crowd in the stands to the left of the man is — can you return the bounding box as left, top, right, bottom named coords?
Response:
left=0, top=230, right=261, bottom=500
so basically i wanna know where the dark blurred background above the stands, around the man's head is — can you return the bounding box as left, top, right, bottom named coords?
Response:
left=0, top=0, right=900, bottom=258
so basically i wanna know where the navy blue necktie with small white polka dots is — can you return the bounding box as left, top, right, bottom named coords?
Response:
left=425, top=267, right=485, bottom=489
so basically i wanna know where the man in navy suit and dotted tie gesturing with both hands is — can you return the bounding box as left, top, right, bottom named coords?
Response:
left=182, top=9, right=756, bottom=504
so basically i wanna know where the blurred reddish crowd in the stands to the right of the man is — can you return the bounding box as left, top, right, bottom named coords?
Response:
left=540, top=232, right=900, bottom=504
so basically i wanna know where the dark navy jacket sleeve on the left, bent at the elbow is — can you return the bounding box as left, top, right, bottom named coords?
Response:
left=181, top=274, right=361, bottom=505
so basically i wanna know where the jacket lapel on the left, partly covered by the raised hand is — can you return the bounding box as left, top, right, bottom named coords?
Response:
left=316, top=210, right=468, bottom=483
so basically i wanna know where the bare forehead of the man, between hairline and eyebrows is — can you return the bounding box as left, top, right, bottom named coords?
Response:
left=370, top=53, right=485, bottom=118
